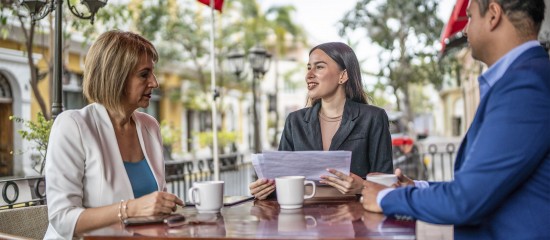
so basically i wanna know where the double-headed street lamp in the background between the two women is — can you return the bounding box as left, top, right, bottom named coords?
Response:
left=227, top=46, right=271, bottom=153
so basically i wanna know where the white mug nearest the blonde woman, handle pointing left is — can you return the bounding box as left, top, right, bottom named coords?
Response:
left=188, top=181, right=223, bottom=213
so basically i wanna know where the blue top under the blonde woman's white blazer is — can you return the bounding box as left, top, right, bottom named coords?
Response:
left=124, top=158, right=158, bottom=198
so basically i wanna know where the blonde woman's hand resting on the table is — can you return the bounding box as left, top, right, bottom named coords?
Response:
left=127, top=191, right=185, bottom=217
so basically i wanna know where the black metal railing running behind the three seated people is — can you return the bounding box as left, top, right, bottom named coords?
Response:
left=0, top=142, right=464, bottom=209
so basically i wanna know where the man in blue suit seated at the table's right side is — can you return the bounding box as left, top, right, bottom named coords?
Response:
left=362, top=0, right=550, bottom=239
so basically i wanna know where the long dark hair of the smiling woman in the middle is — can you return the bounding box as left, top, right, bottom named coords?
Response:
left=308, top=42, right=368, bottom=106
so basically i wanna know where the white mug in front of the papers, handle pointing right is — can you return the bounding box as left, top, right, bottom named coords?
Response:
left=275, top=176, right=315, bottom=209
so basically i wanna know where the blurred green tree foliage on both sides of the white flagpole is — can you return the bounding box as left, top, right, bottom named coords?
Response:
left=125, top=0, right=305, bottom=154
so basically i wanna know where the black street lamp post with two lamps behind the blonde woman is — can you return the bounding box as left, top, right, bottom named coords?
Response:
left=21, top=0, right=108, bottom=119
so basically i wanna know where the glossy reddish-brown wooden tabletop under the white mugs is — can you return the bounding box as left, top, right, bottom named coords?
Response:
left=84, top=199, right=452, bottom=239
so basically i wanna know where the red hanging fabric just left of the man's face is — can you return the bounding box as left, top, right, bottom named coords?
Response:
left=441, top=0, right=468, bottom=53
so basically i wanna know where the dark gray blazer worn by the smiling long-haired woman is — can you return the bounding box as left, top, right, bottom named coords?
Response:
left=279, top=99, right=393, bottom=178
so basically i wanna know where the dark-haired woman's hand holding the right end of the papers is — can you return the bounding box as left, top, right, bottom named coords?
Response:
left=319, top=168, right=365, bottom=194
